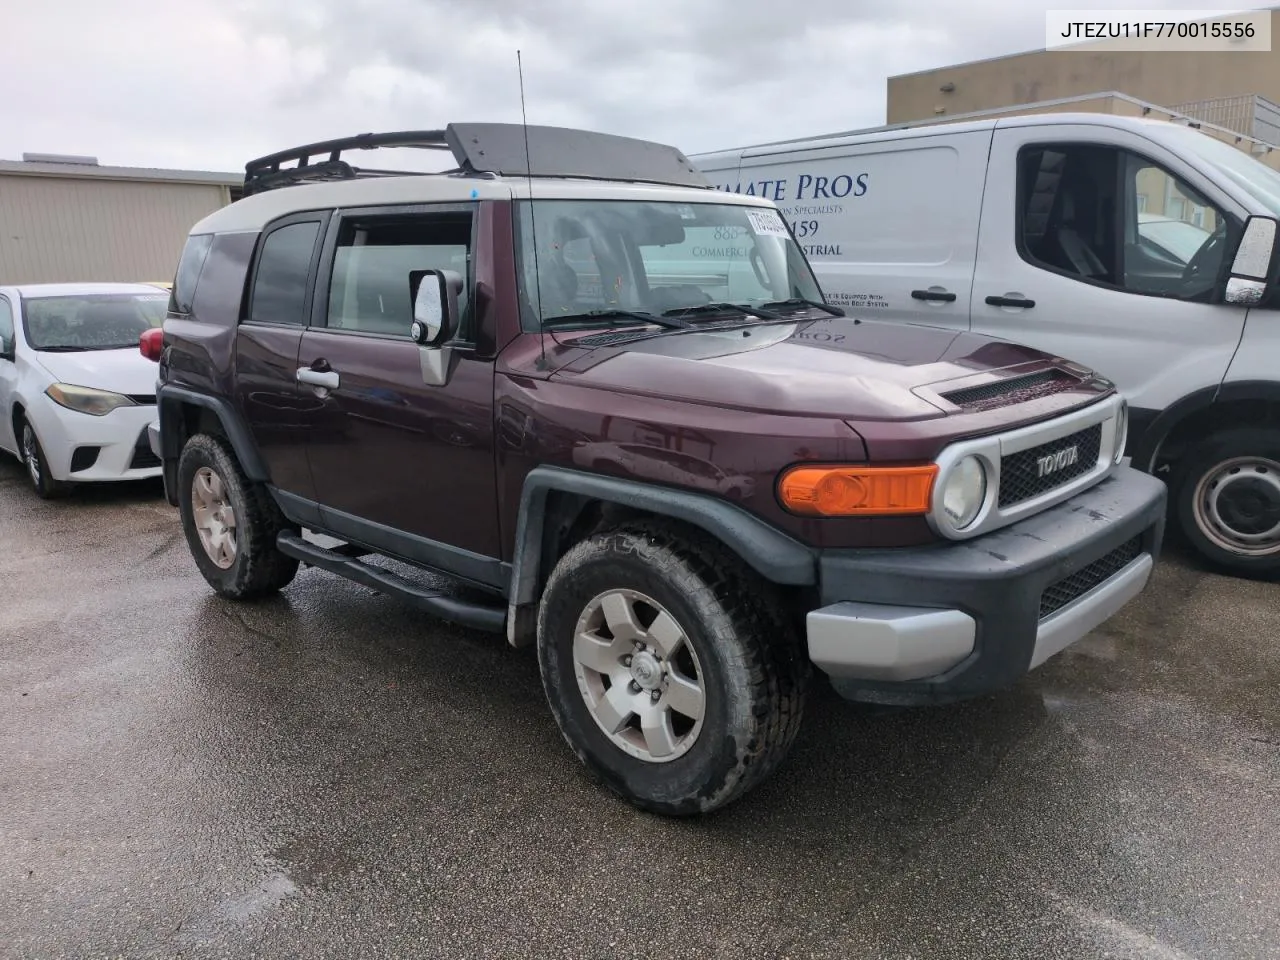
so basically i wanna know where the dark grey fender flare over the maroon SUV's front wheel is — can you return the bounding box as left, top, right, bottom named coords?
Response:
left=509, top=466, right=818, bottom=616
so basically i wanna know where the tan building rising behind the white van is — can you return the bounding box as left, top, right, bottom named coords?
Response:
left=887, top=10, right=1280, bottom=158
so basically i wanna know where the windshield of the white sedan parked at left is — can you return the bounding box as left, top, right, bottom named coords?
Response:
left=22, top=291, right=169, bottom=352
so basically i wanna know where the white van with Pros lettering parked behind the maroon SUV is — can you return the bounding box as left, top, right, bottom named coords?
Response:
left=691, top=114, right=1280, bottom=572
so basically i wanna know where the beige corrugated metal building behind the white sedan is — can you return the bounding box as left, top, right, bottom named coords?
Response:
left=0, top=154, right=243, bottom=284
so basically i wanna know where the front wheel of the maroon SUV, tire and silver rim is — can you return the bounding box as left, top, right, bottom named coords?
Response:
left=538, top=522, right=812, bottom=817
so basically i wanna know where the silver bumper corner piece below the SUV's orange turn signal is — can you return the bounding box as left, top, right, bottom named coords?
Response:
left=805, top=602, right=978, bottom=681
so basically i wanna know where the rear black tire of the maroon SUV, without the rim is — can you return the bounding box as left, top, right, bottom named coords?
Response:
left=178, top=434, right=298, bottom=600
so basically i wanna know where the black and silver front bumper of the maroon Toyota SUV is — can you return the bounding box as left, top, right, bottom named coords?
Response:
left=806, top=467, right=1166, bottom=704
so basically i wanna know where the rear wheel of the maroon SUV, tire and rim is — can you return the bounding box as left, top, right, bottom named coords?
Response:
left=178, top=434, right=298, bottom=600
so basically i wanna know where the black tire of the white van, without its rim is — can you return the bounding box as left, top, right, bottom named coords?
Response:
left=1170, top=426, right=1280, bottom=576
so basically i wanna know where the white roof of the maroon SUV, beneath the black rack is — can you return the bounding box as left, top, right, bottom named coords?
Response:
left=191, top=174, right=773, bottom=234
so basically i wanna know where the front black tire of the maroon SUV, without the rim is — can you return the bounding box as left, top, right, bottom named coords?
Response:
left=538, top=521, right=812, bottom=817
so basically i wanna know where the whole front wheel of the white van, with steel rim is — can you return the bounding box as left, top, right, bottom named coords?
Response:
left=1172, top=428, right=1280, bottom=573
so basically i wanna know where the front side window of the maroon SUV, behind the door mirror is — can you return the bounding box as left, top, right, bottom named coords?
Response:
left=328, top=214, right=471, bottom=338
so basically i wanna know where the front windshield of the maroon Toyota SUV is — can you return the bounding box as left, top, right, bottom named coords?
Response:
left=518, top=200, right=822, bottom=332
